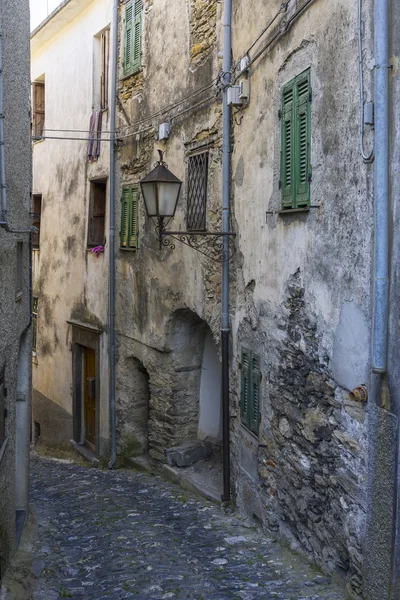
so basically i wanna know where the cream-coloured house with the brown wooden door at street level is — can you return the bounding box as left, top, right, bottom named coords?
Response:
left=31, top=0, right=111, bottom=455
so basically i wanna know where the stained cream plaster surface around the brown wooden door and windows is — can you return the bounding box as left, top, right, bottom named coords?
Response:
left=31, top=0, right=111, bottom=452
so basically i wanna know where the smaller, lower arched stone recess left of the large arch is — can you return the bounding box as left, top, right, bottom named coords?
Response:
left=117, top=356, right=150, bottom=456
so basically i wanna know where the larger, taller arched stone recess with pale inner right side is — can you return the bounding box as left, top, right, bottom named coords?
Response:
left=149, top=308, right=220, bottom=461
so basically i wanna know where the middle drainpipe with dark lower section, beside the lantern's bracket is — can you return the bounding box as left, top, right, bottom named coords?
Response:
left=221, top=0, right=232, bottom=502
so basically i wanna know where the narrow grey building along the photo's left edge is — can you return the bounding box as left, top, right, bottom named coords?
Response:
left=0, top=0, right=32, bottom=584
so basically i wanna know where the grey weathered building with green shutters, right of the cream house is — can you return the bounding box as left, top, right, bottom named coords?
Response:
left=112, top=0, right=398, bottom=598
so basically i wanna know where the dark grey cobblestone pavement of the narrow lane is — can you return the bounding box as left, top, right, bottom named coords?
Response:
left=7, top=457, right=343, bottom=600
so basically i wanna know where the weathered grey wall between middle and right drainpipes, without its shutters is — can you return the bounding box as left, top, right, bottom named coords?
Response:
left=232, top=0, right=373, bottom=593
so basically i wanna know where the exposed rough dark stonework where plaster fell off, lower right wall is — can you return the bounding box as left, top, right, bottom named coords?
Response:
left=235, top=270, right=367, bottom=594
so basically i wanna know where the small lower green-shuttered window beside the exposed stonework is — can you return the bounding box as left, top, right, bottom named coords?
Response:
left=240, top=348, right=261, bottom=435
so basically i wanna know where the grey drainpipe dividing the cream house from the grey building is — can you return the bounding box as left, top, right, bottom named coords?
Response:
left=108, top=0, right=118, bottom=469
